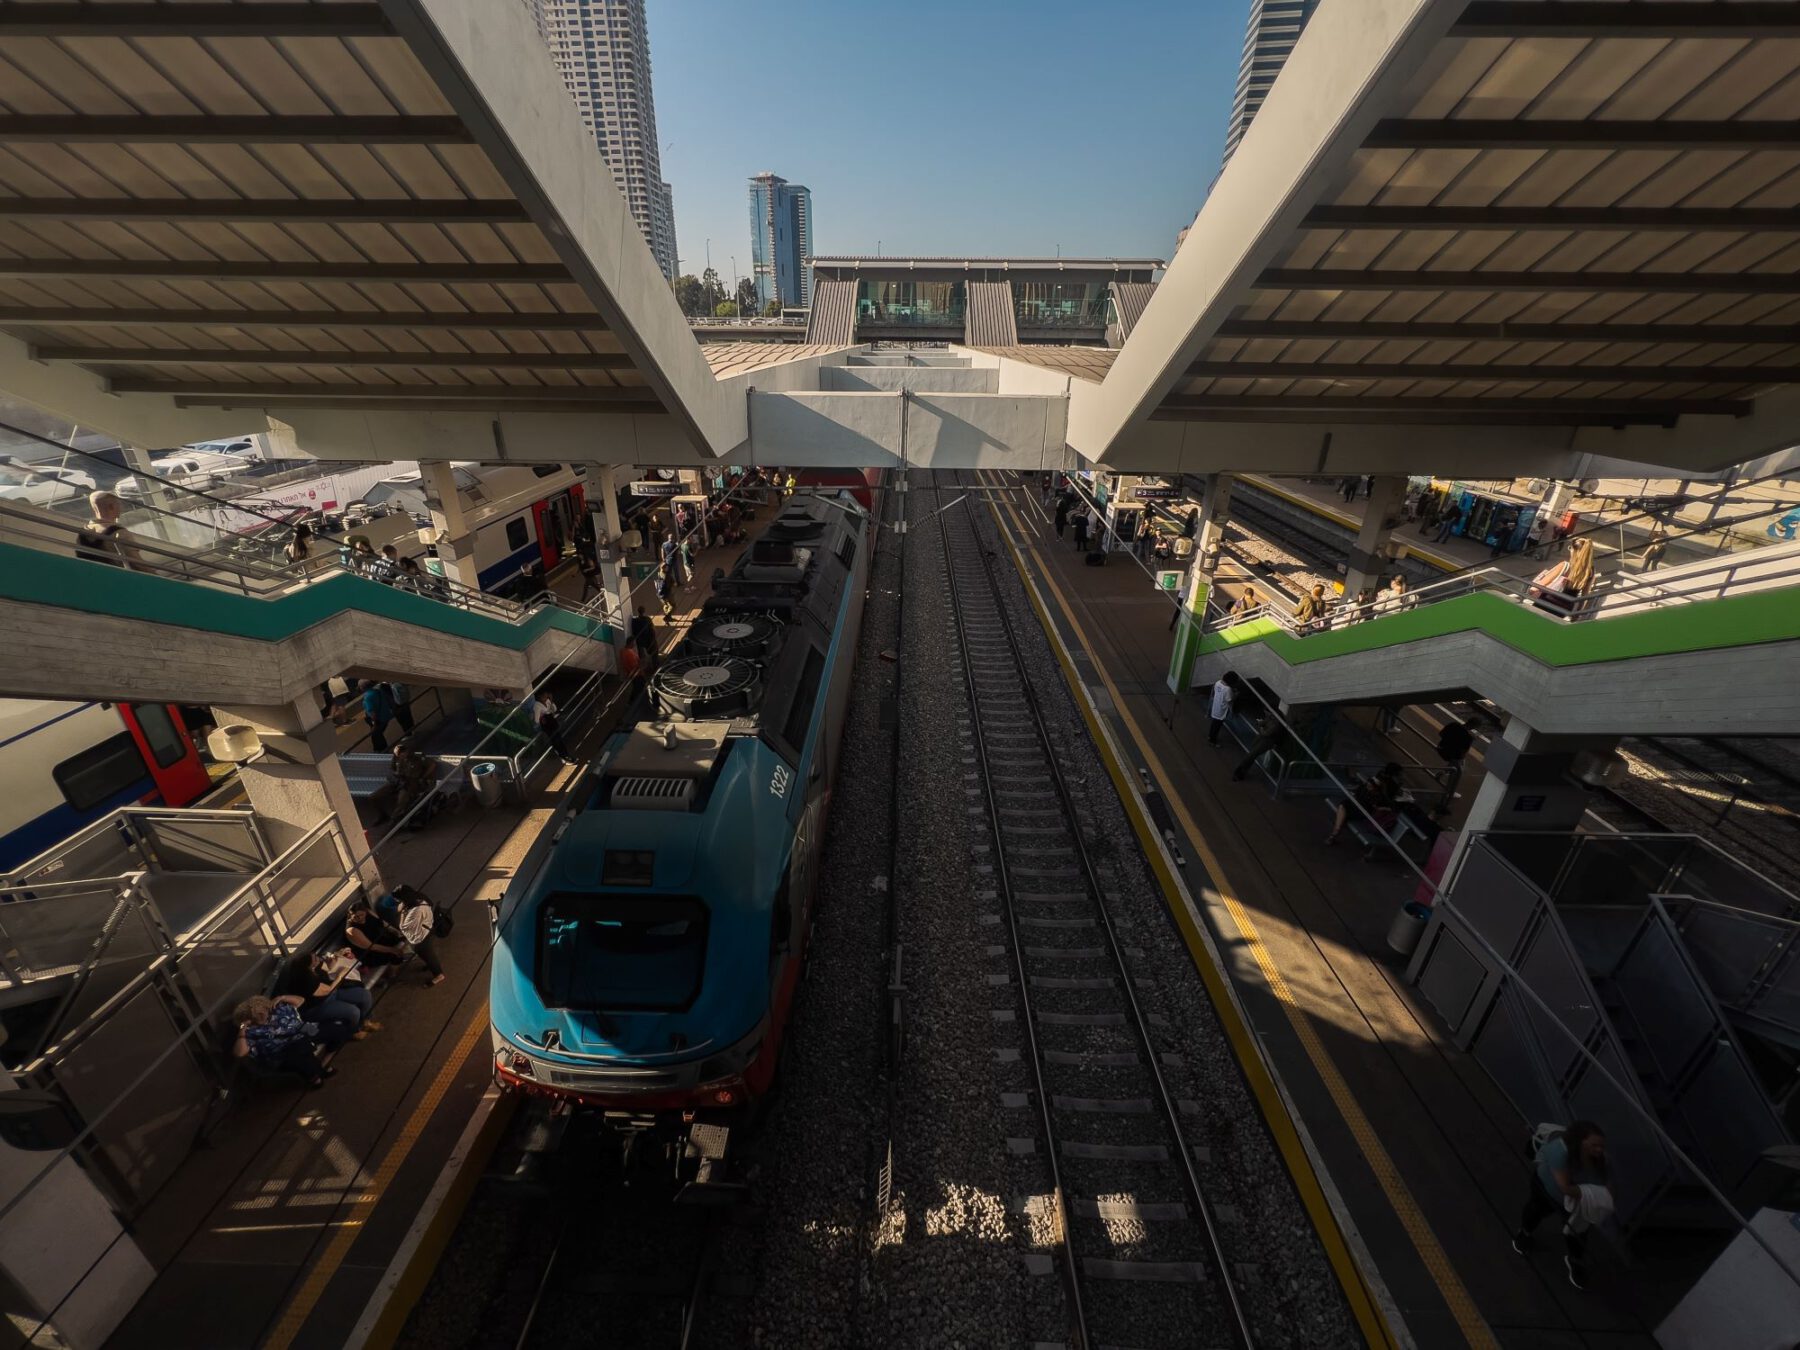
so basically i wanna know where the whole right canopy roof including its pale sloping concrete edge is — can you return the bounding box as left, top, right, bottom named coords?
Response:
left=1071, top=0, right=1800, bottom=475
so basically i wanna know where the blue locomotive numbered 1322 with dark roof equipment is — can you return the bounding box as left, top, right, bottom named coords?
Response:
left=490, top=493, right=873, bottom=1184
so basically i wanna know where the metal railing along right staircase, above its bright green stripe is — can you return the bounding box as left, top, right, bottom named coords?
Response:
left=1204, top=536, right=1800, bottom=637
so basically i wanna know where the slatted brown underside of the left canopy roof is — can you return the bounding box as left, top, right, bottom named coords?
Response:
left=0, top=0, right=662, bottom=412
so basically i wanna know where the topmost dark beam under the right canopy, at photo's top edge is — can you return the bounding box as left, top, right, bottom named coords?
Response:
left=1451, top=0, right=1800, bottom=40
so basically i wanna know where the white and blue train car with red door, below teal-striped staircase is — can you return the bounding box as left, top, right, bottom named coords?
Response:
left=0, top=698, right=211, bottom=871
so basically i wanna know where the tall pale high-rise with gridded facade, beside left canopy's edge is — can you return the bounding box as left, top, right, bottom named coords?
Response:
left=524, top=0, right=677, bottom=281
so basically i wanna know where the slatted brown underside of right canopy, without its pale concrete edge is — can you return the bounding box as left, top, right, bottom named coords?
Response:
left=1154, top=0, right=1800, bottom=425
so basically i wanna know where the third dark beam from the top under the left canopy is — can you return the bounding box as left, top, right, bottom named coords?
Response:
left=0, top=196, right=531, bottom=225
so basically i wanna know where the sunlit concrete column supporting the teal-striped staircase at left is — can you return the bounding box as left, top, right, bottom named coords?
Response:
left=212, top=695, right=381, bottom=889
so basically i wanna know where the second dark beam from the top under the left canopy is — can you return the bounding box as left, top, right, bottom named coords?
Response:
left=0, top=116, right=475, bottom=146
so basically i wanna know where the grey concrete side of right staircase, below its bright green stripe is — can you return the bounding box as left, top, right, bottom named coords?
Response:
left=1193, top=630, right=1800, bottom=736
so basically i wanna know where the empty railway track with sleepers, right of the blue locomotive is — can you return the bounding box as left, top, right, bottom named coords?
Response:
left=936, top=475, right=1253, bottom=1350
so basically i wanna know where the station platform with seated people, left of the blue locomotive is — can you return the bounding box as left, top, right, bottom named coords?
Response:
left=93, top=529, right=752, bottom=1350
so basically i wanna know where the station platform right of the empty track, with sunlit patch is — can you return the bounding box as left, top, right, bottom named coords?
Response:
left=986, top=475, right=1667, bottom=1350
